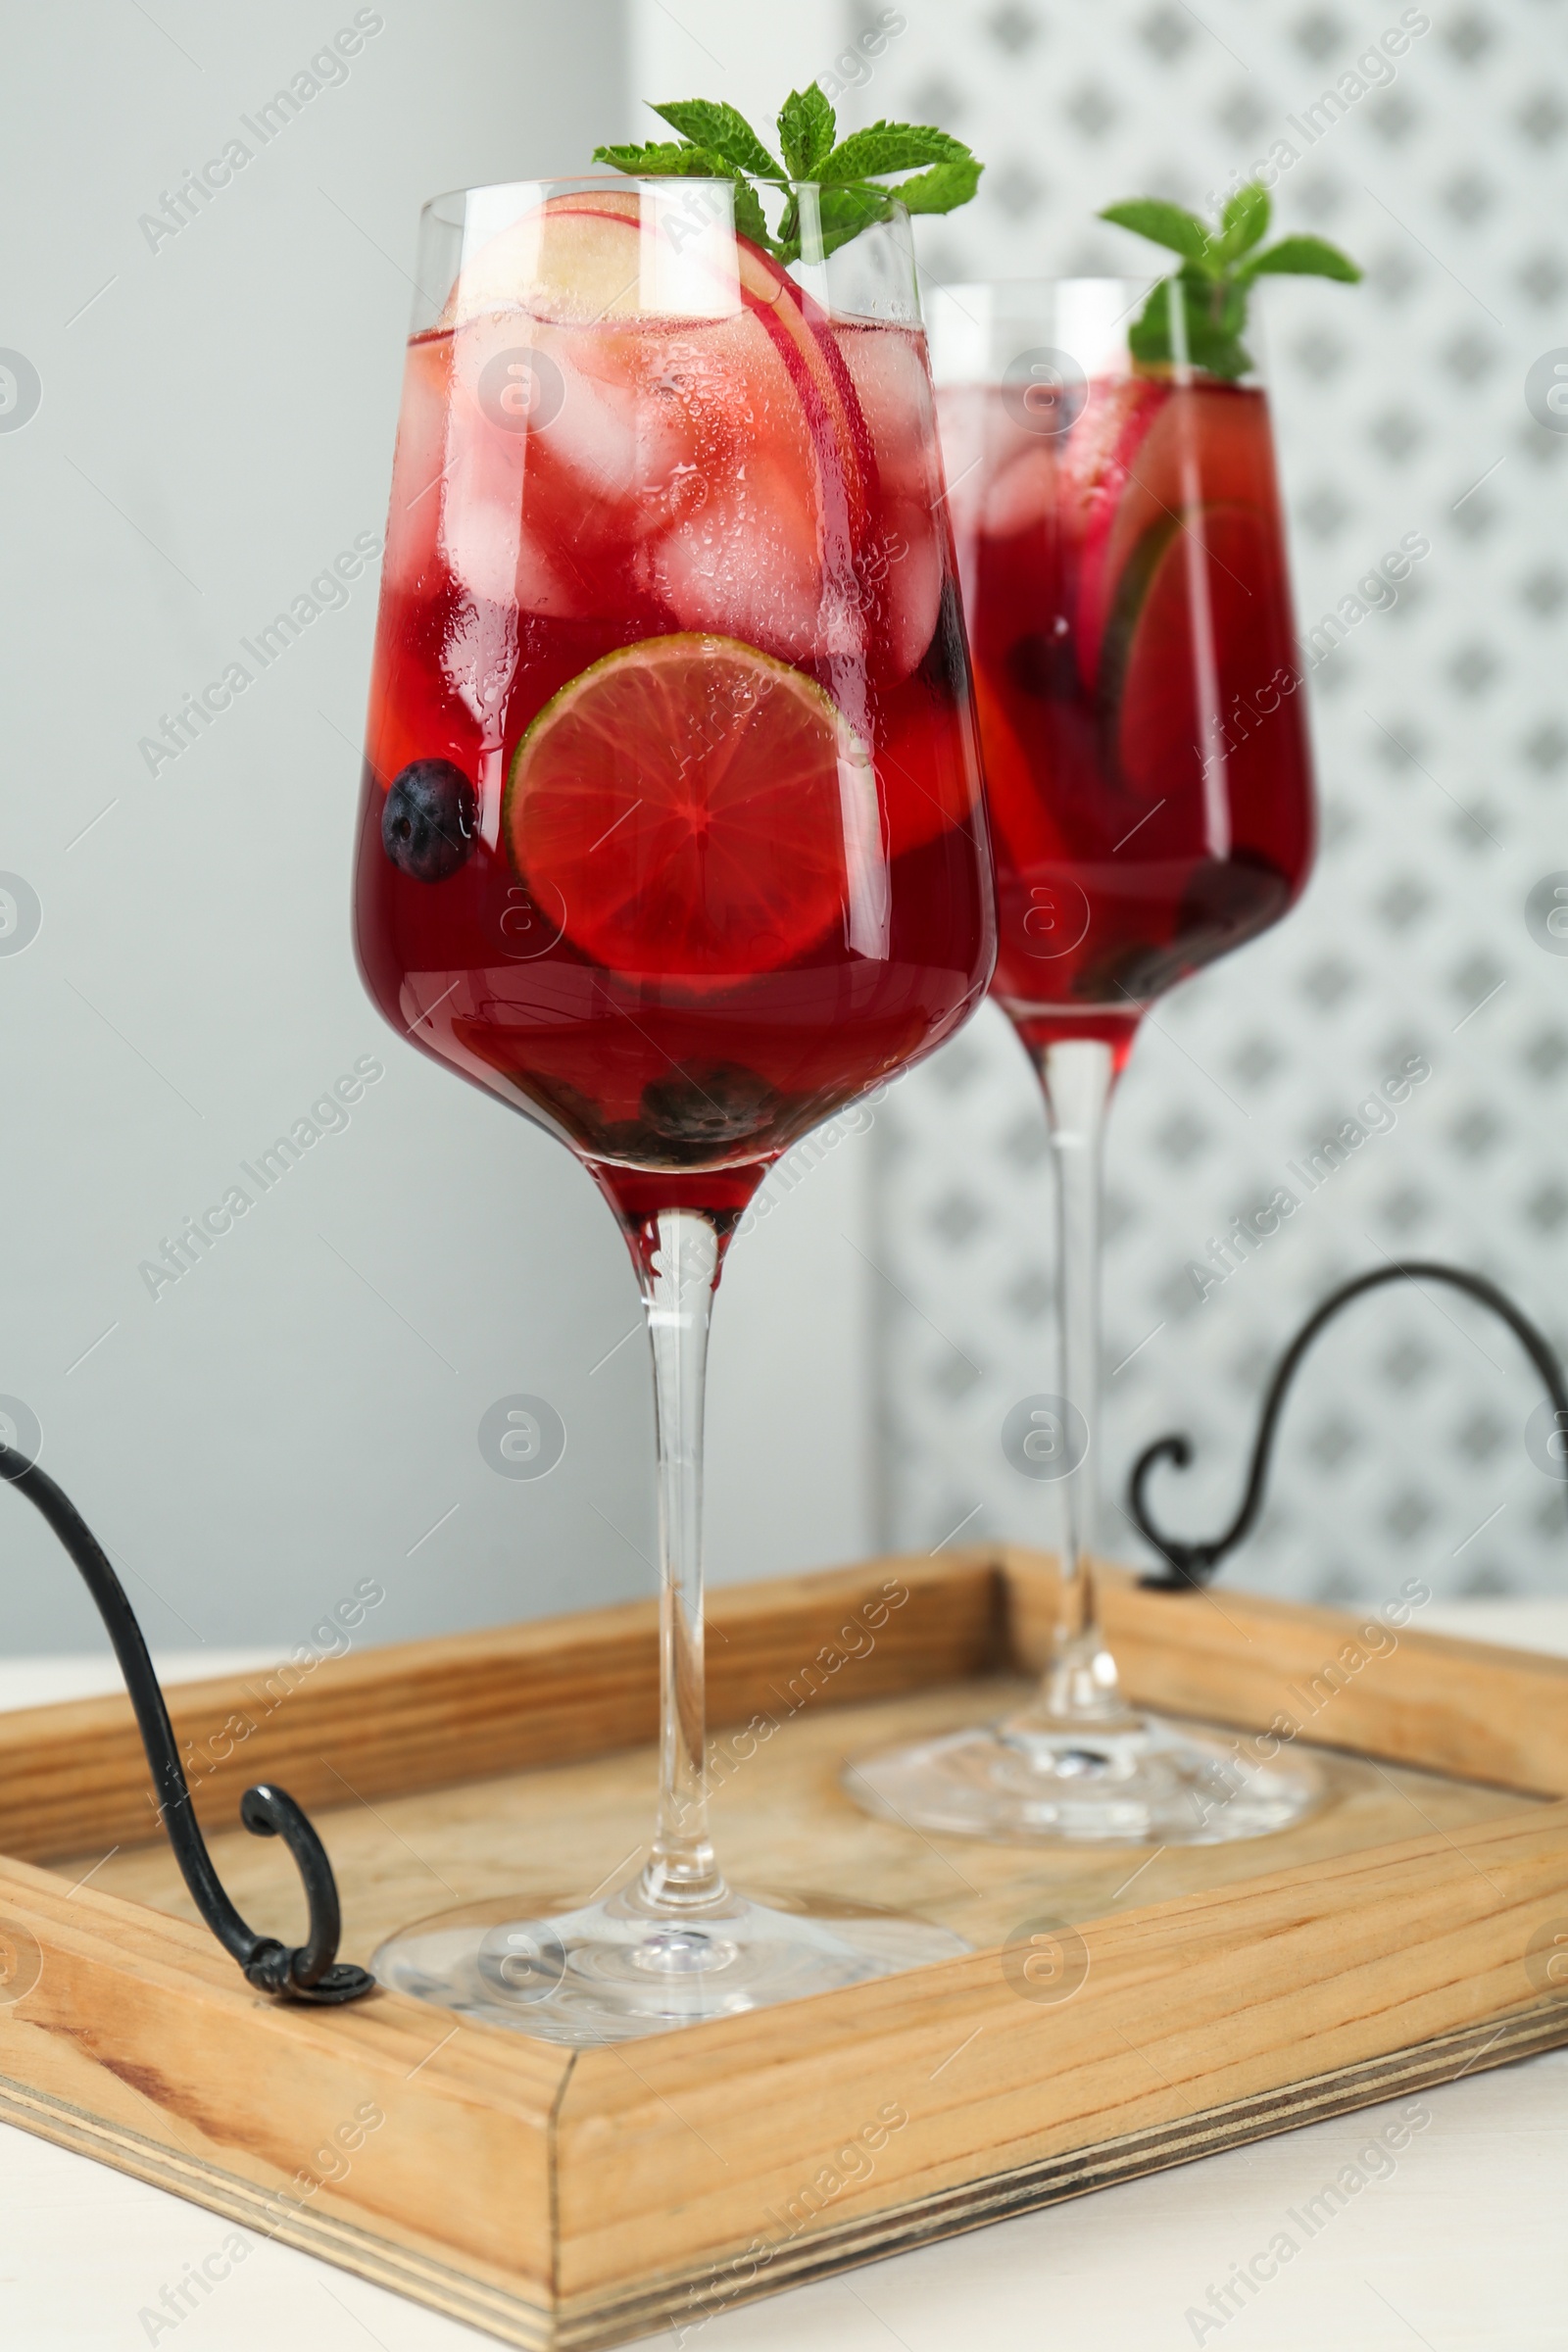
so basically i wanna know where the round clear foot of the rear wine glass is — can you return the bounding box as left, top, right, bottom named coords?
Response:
left=844, top=1715, right=1324, bottom=1846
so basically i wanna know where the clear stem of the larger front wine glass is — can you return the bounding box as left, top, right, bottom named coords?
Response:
left=637, top=1209, right=729, bottom=1912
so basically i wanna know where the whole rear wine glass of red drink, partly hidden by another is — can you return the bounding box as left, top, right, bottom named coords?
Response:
left=847, top=277, right=1319, bottom=1844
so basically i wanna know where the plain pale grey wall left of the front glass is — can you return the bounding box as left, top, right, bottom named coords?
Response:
left=0, top=0, right=681, bottom=1651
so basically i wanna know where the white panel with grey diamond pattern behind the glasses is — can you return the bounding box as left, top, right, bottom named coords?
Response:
left=844, top=0, right=1568, bottom=1599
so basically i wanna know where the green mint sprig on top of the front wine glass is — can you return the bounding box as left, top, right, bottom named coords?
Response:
left=592, top=82, right=985, bottom=264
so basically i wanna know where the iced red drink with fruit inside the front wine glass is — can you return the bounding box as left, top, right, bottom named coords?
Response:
left=355, top=198, right=995, bottom=1221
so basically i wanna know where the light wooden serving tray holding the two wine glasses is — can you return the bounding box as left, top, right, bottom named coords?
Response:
left=0, top=1552, right=1568, bottom=2347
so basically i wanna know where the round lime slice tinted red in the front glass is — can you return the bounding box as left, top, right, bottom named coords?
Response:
left=501, top=635, right=882, bottom=983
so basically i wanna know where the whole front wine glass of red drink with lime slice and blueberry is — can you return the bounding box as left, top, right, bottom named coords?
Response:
left=355, top=176, right=995, bottom=2041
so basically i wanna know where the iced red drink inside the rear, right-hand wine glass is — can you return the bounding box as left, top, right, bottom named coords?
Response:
left=938, top=376, right=1314, bottom=1063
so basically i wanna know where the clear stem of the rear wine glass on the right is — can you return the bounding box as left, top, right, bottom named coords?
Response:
left=1030, top=1037, right=1126, bottom=1729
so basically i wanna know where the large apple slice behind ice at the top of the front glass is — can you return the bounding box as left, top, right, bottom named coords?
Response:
left=442, top=190, right=879, bottom=665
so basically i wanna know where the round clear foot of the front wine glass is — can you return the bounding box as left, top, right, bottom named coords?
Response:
left=371, top=1886, right=971, bottom=2046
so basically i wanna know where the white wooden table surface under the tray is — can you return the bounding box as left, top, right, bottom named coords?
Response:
left=0, top=1601, right=1568, bottom=2352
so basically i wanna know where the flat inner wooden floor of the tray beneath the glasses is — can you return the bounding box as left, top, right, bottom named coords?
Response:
left=52, top=1675, right=1544, bottom=1962
